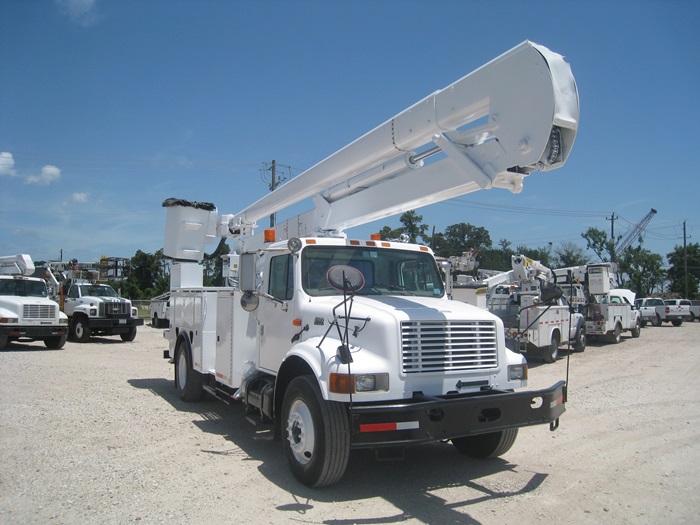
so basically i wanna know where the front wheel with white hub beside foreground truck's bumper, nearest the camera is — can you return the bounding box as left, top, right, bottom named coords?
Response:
left=282, top=376, right=350, bottom=487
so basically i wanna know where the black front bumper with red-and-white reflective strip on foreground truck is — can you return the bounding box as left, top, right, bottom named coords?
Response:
left=351, top=381, right=566, bottom=448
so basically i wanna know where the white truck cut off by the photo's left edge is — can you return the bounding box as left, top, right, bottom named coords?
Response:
left=0, top=254, right=68, bottom=350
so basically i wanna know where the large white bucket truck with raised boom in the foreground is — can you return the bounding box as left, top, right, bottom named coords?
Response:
left=163, top=42, right=579, bottom=487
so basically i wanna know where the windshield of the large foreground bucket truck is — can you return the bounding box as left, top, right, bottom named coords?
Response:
left=301, top=246, right=444, bottom=297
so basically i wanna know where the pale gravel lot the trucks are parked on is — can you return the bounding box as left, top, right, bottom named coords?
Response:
left=0, top=323, right=700, bottom=525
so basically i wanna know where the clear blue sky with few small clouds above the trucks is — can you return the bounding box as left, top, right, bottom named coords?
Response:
left=0, top=0, right=700, bottom=261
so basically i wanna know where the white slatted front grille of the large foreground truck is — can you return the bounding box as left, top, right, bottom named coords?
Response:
left=401, top=321, right=498, bottom=374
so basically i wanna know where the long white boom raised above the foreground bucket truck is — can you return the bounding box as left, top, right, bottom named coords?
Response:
left=217, top=41, right=579, bottom=249
